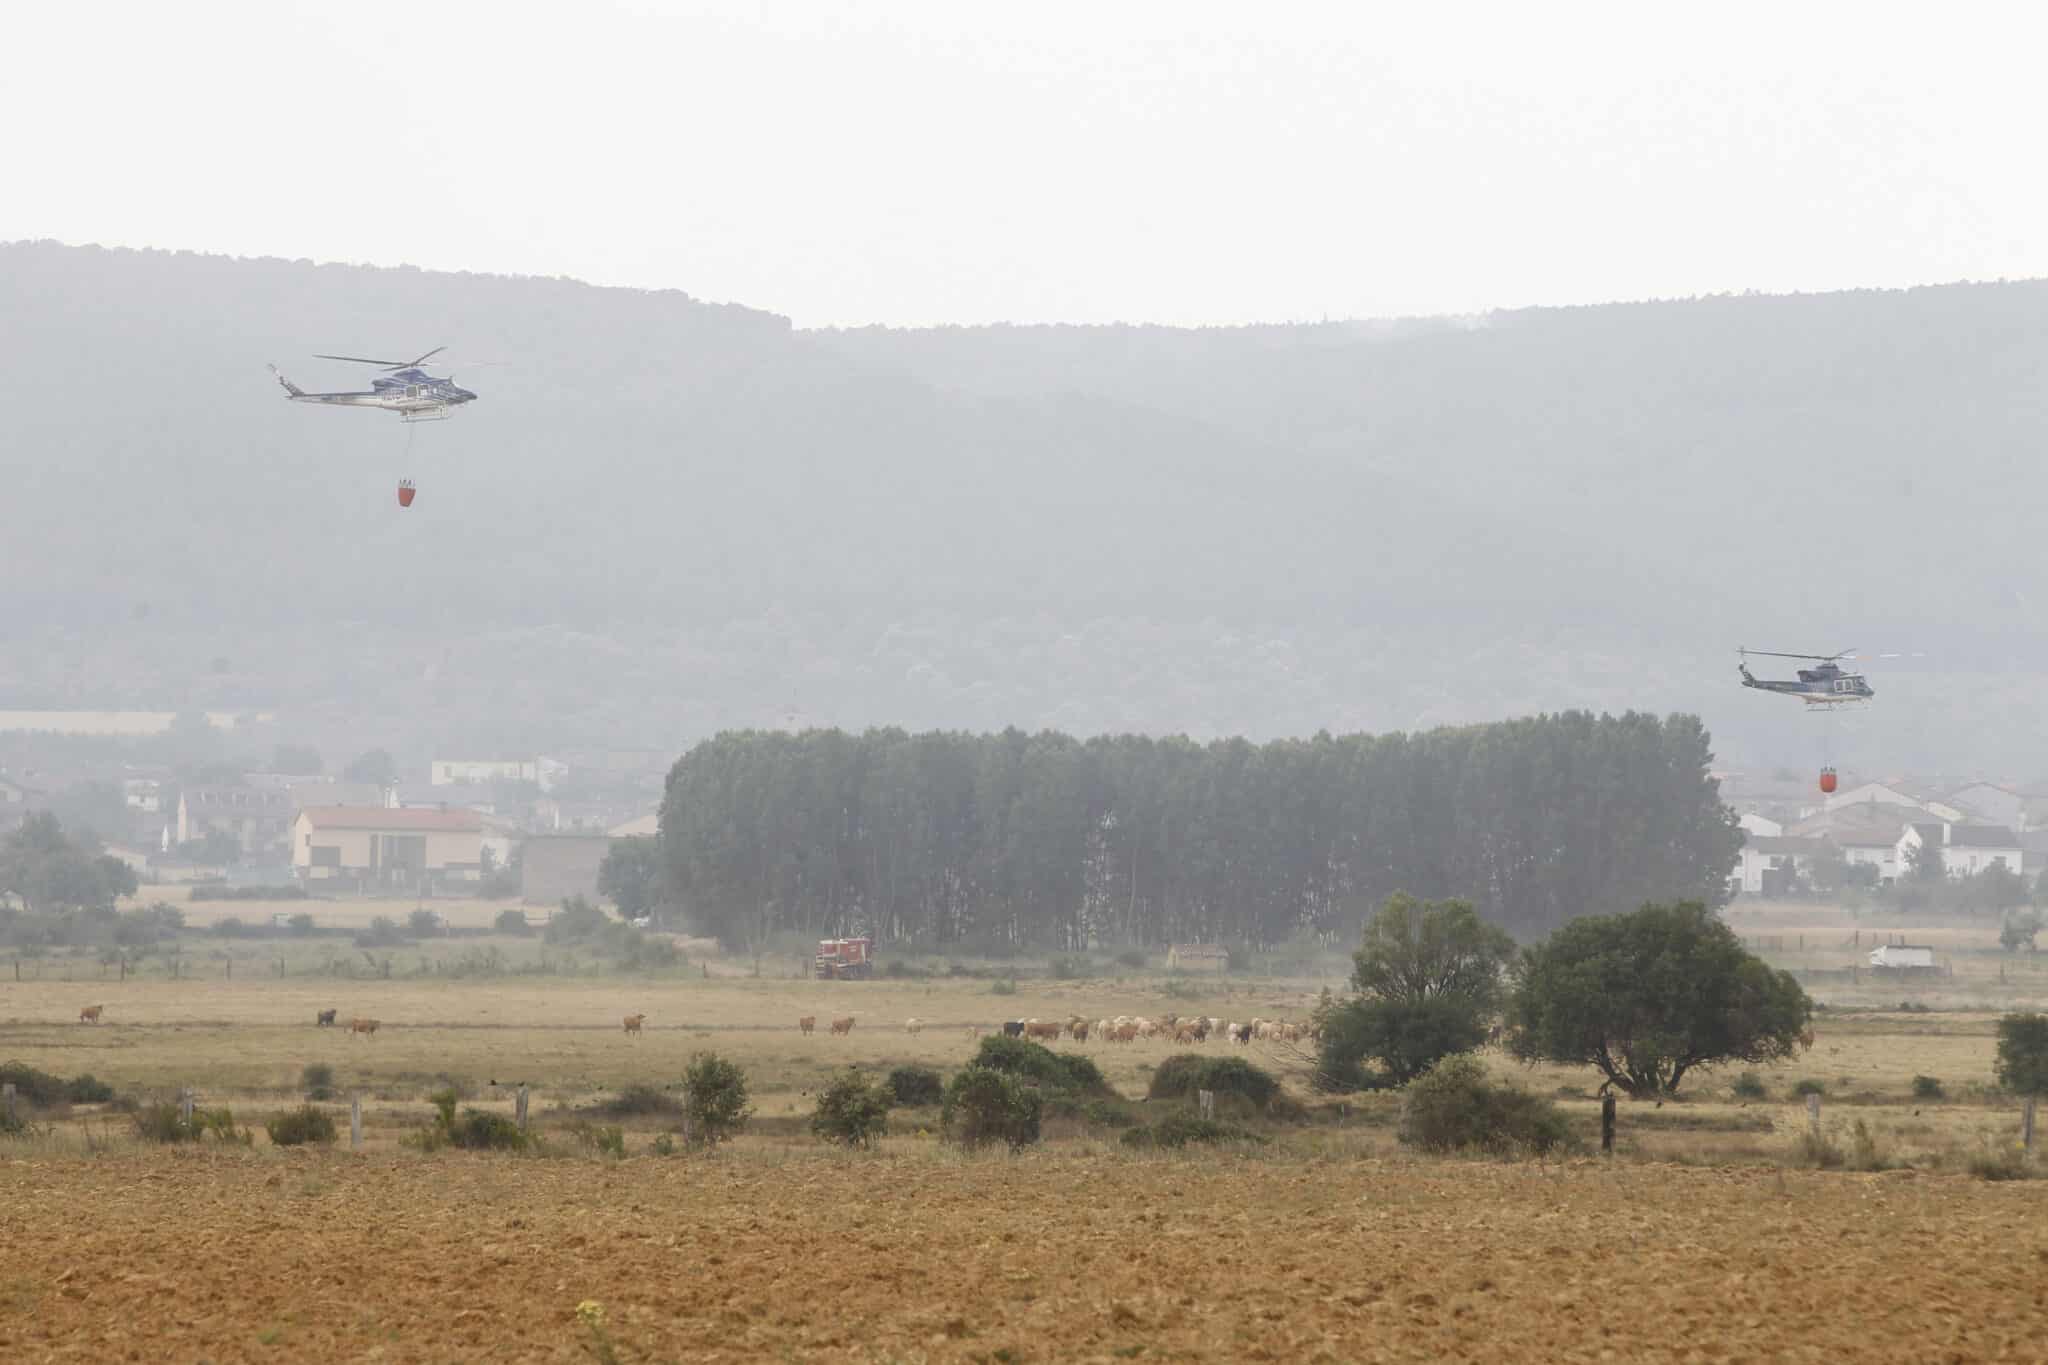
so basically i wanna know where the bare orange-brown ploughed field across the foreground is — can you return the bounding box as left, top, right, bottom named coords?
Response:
left=0, top=1148, right=2048, bottom=1363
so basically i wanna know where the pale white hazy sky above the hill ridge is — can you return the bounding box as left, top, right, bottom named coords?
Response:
left=16, top=0, right=2048, bottom=325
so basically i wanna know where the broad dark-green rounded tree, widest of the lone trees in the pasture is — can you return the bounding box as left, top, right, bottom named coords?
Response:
left=1507, top=902, right=1812, bottom=1095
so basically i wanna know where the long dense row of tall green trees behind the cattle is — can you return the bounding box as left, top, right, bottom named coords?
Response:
left=662, top=712, right=1741, bottom=952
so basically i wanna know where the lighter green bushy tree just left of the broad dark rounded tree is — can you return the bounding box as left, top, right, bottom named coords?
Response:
left=1317, top=892, right=1516, bottom=1089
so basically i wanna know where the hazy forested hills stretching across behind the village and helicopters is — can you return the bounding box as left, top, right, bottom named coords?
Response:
left=0, top=244, right=2048, bottom=776
